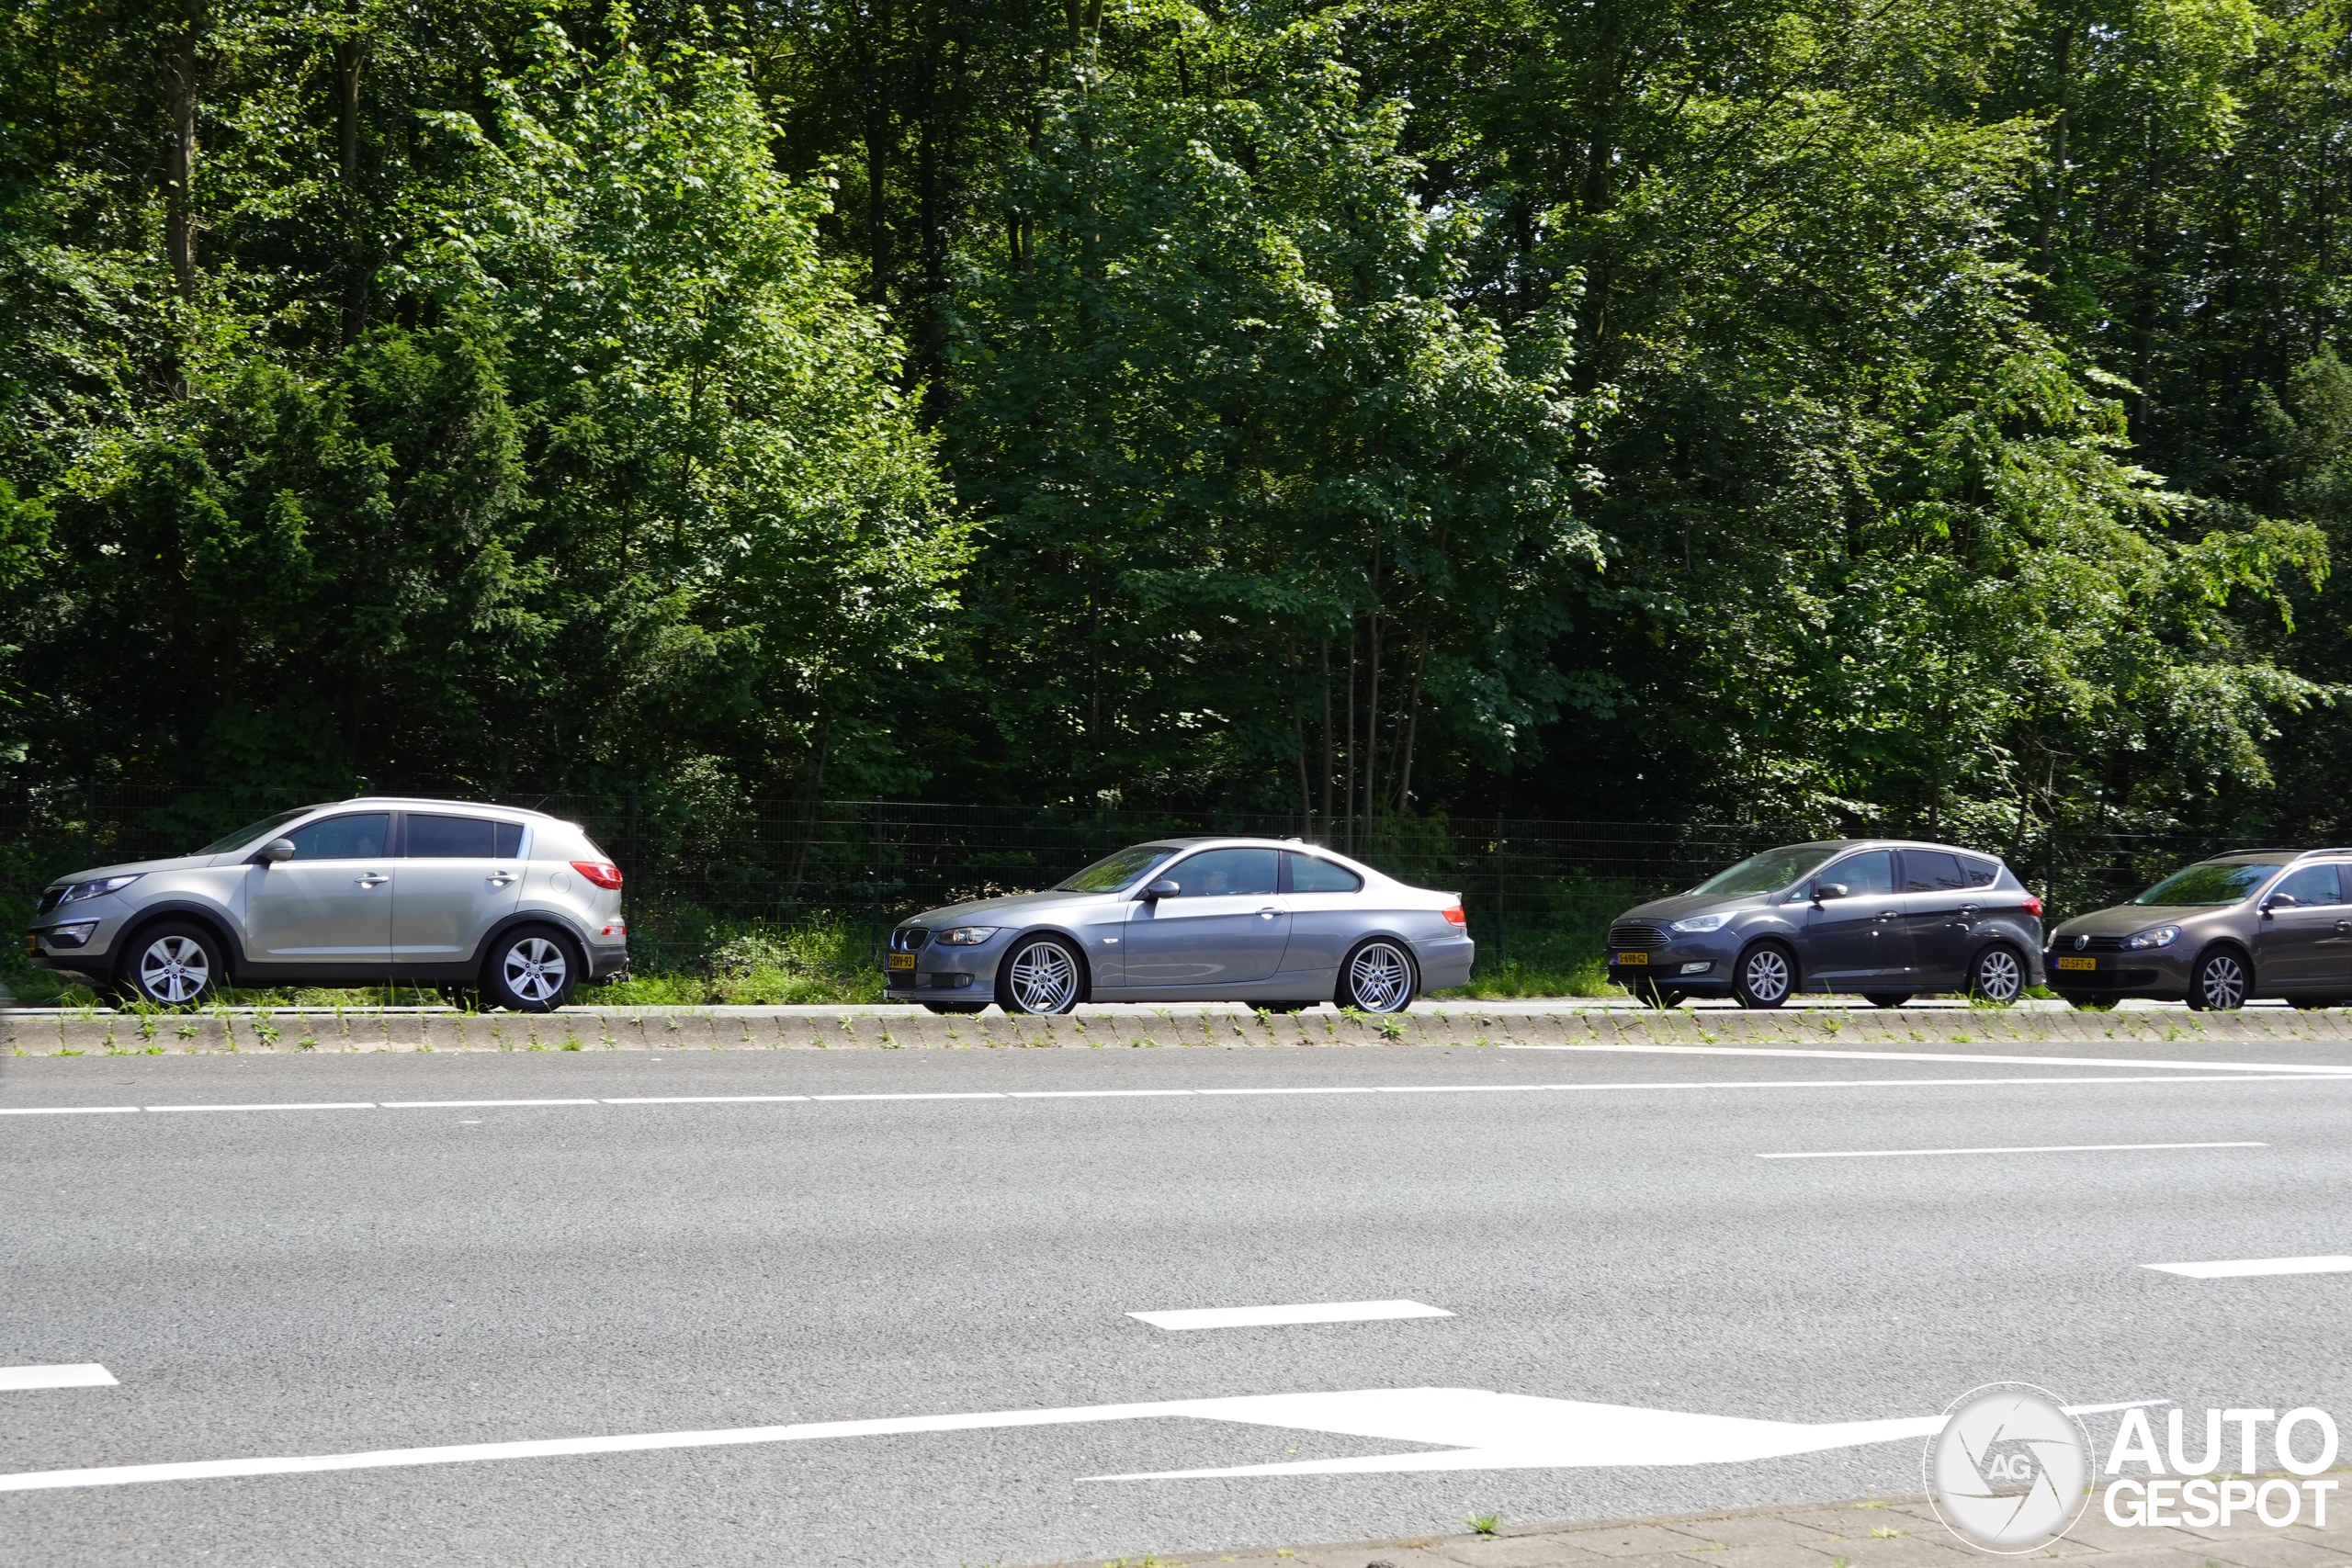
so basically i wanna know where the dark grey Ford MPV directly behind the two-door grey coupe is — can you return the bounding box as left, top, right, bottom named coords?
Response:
left=1609, top=840, right=2041, bottom=1006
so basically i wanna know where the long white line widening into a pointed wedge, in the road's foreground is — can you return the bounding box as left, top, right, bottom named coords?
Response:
left=0, top=1389, right=2154, bottom=1493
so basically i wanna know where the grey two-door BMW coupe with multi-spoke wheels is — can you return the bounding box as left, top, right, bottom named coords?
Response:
left=882, top=840, right=1475, bottom=1013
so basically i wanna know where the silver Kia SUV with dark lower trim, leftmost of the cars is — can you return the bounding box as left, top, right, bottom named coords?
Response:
left=26, top=797, right=628, bottom=1013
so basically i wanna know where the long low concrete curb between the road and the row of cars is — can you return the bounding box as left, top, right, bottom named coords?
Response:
left=0, top=1009, right=2352, bottom=1055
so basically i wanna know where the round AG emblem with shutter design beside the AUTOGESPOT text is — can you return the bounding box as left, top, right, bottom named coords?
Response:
left=1927, top=1382, right=2091, bottom=1554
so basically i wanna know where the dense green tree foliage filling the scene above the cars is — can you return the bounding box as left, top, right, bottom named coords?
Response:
left=0, top=0, right=2352, bottom=846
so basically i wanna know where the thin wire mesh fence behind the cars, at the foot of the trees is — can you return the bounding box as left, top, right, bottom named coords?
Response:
left=0, top=785, right=2342, bottom=971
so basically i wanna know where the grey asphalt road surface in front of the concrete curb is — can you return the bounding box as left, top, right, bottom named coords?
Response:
left=0, top=1046, right=2352, bottom=1568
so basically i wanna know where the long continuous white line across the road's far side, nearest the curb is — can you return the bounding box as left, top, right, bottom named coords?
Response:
left=0, top=1066, right=2352, bottom=1117
